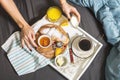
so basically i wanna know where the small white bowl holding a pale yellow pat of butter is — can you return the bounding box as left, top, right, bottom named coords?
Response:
left=55, top=55, right=68, bottom=68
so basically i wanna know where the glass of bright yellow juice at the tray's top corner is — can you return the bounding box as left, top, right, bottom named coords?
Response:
left=47, top=6, right=62, bottom=22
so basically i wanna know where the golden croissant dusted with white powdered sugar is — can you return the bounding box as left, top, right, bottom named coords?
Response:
left=39, top=24, right=69, bottom=44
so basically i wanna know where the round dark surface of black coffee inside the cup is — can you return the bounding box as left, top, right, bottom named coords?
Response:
left=79, top=39, right=91, bottom=51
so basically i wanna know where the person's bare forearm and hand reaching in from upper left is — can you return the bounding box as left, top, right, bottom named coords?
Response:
left=0, top=0, right=37, bottom=50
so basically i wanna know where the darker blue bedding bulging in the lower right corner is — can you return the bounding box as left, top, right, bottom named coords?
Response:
left=105, top=43, right=120, bottom=80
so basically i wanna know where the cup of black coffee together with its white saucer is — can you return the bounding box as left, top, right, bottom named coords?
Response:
left=72, top=36, right=94, bottom=58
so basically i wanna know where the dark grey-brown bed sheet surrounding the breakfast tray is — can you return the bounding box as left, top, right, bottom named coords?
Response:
left=0, top=0, right=111, bottom=80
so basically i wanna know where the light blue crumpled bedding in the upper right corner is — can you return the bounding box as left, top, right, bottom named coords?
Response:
left=69, top=0, right=120, bottom=45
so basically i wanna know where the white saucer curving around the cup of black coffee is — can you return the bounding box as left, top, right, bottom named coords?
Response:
left=72, top=36, right=94, bottom=58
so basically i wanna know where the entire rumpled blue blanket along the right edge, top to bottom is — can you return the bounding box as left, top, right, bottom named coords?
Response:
left=69, top=0, right=120, bottom=80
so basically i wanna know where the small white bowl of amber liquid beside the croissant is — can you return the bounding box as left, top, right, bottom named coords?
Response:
left=38, top=35, right=52, bottom=48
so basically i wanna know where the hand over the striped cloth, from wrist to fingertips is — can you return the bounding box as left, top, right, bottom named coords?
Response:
left=21, top=25, right=37, bottom=51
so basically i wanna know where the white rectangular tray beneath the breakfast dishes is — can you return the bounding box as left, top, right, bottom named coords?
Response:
left=32, top=16, right=103, bottom=80
